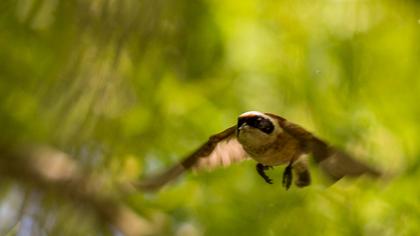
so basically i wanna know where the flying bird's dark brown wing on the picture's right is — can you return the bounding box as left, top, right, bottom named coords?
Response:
left=268, top=114, right=381, bottom=182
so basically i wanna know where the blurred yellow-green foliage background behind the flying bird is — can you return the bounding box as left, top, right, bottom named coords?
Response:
left=0, top=0, right=420, bottom=235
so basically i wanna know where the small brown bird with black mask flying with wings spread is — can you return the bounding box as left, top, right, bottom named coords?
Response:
left=135, top=111, right=381, bottom=191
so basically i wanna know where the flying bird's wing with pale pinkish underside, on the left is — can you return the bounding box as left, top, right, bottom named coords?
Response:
left=135, top=126, right=248, bottom=191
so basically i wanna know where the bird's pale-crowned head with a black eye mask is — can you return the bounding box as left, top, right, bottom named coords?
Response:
left=237, top=111, right=282, bottom=145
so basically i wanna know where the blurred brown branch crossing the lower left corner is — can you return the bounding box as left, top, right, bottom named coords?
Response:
left=0, top=146, right=158, bottom=236
